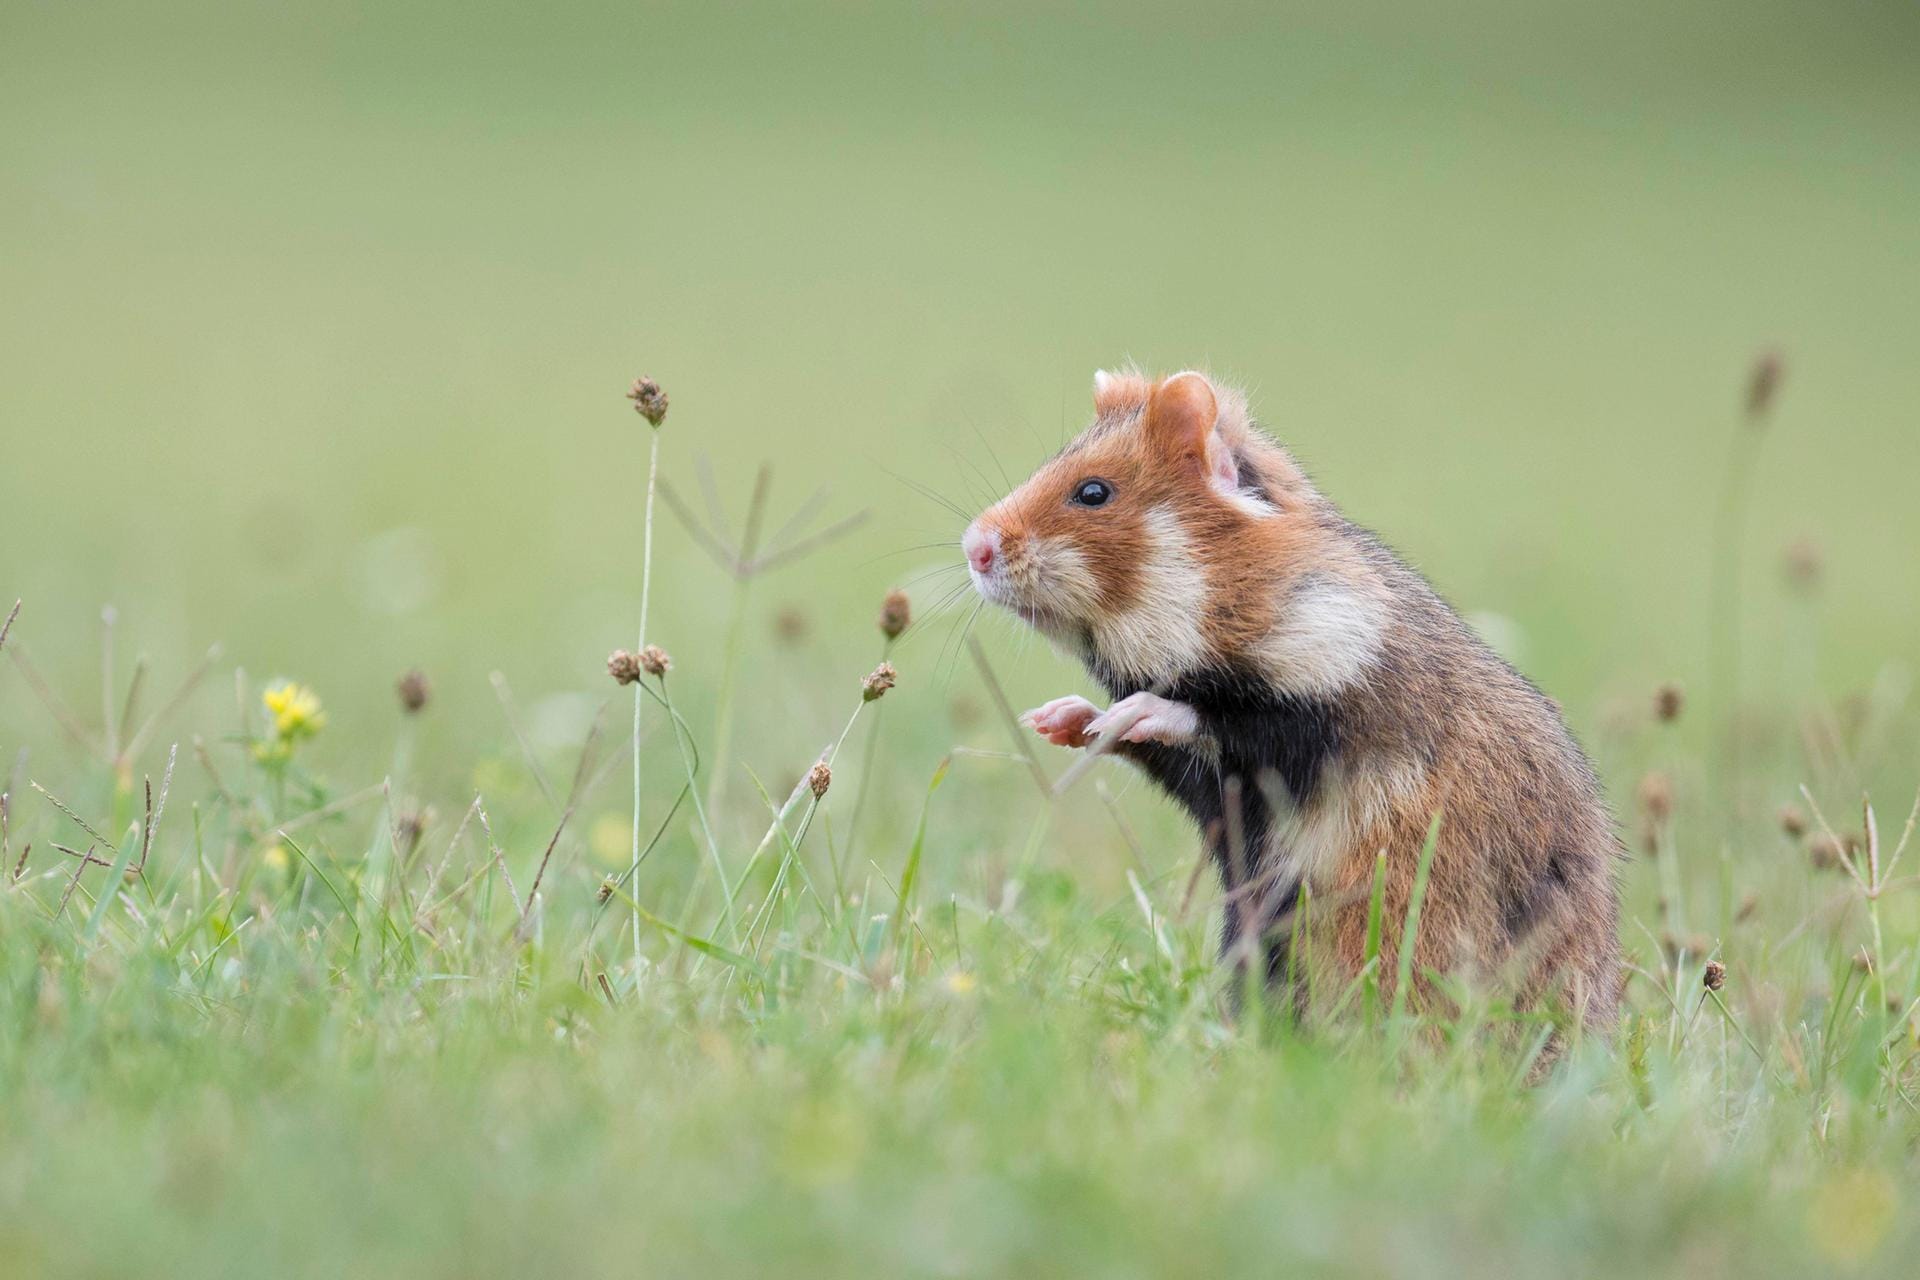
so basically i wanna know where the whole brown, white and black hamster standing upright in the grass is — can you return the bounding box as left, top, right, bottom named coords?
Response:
left=962, top=370, right=1622, bottom=1032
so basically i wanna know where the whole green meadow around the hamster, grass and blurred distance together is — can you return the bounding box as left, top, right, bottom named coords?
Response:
left=0, top=0, right=1920, bottom=1276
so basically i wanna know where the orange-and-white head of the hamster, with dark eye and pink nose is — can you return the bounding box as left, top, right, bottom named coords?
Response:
left=960, top=372, right=1336, bottom=687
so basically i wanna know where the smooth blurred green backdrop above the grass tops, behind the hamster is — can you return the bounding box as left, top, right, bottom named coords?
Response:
left=0, top=0, right=1920, bottom=782
